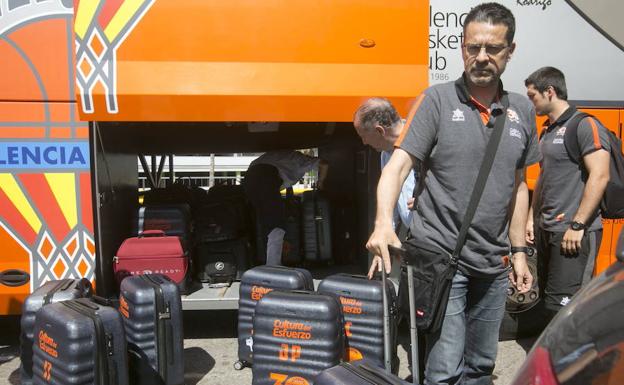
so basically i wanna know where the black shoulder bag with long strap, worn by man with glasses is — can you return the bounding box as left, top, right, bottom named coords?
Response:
left=400, top=95, right=509, bottom=333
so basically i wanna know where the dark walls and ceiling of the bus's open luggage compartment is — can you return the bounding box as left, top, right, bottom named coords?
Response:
left=89, top=122, right=380, bottom=308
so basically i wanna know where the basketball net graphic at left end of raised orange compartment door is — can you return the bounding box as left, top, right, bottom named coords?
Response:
left=74, top=0, right=154, bottom=114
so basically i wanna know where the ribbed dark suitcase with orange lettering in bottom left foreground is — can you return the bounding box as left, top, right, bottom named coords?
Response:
left=33, top=298, right=128, bottom=385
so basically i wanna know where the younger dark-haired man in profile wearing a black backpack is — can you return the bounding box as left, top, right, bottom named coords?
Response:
left=525, top=67, right=609, bottom=316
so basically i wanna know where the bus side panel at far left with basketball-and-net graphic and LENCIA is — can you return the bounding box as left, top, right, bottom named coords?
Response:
left=0, top=0, right=95, bottom=314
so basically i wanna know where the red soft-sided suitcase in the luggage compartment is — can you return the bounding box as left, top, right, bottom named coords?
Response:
left=113, top=230, right=189, bottom=293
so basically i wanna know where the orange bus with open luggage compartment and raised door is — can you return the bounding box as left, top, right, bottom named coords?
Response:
left=0, top=0, right=624, bottom=314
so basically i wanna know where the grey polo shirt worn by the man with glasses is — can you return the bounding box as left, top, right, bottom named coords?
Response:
left=397, top=77, right=539, bottom=277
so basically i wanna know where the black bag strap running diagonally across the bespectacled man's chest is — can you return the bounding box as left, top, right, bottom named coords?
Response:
left=451, top=94, right=509, bottom=264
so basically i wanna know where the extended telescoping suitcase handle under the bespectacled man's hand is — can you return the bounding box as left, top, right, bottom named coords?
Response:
left=388, top=245, right=420, bottom=385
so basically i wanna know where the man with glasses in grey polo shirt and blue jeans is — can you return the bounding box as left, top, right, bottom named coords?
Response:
left=367, top=3, right=538, bottom=385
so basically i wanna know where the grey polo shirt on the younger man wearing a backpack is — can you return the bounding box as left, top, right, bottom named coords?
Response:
left=539, top=107, right=610, bottom=232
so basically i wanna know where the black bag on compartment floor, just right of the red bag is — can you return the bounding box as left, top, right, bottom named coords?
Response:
left=195, top=238, right=249, bottom=285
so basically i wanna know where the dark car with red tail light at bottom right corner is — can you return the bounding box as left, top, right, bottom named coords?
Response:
left=511, top=231, right=624, bottom=385
